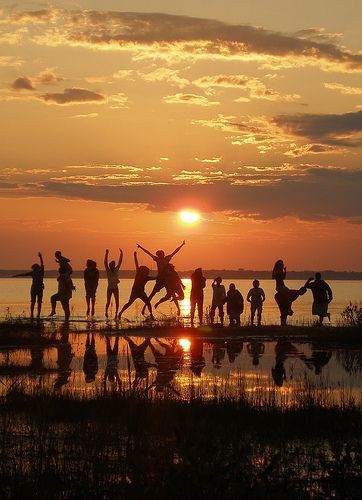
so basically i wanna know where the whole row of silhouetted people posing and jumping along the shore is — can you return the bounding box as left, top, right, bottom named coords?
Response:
left=11, top=241, right=333, bottom=327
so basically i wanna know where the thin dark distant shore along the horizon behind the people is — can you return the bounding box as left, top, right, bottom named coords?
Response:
left=0, top=269, right=362, bottom=281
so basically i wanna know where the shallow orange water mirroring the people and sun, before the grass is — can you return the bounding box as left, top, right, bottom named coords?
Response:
left=0, top=330, right=362, bottom=406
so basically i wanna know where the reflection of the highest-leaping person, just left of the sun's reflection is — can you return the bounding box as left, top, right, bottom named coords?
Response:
left=150, top=339, right=183, bottom=397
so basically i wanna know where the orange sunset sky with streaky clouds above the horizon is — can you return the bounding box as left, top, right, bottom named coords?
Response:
left=0, top=0, right=362, bottom=271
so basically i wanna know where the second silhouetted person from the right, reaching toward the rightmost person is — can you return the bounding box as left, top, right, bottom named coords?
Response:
left=272, top=260, right=307, bottom=326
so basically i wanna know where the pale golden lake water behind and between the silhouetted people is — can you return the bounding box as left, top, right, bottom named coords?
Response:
left=0, top=278, right=362, bottom=324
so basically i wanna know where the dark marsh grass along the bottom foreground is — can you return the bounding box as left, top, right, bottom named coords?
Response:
left=0, top=389, right=362, bottom=499
